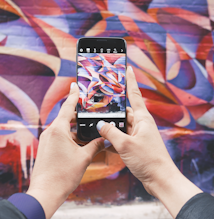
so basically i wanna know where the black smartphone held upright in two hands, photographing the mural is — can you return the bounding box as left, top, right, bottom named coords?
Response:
left=77, top=37, right=127, bottom=141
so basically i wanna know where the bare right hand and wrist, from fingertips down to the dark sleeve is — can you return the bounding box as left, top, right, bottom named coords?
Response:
left=97, top=67, right=202, bottom=218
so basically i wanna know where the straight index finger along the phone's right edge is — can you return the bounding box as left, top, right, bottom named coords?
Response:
left=127, top=66, right=149, bottom=121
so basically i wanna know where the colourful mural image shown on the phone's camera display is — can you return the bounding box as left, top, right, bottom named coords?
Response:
left=78, top=53, right=126, bottom=118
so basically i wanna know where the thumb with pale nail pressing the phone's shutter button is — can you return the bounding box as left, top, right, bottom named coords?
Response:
left=97, top=121, right=128, bottom=152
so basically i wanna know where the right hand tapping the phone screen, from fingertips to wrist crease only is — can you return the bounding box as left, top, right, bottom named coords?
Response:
left=98, top=67, right=174, bottom=194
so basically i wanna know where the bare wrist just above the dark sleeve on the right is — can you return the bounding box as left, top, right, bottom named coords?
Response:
left=144, top=161, right=202, bottom=218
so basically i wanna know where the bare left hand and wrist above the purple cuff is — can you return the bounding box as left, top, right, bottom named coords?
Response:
left=27, top=83, right=104, bottom=219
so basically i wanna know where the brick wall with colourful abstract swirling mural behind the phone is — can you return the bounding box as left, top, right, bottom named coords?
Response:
left=0, top=0, right=214, bottom=203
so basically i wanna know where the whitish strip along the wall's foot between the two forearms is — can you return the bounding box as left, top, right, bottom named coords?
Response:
left=52, top=202, right=172, bottom=219
